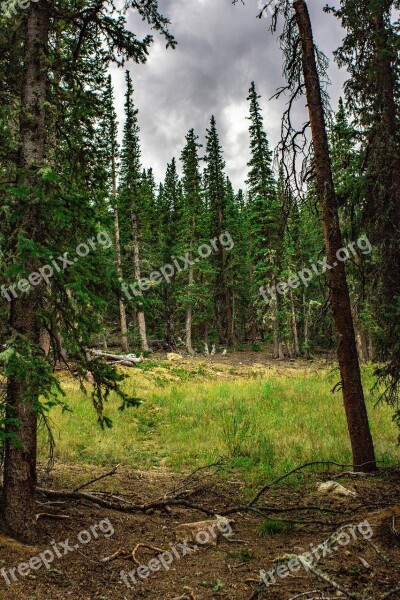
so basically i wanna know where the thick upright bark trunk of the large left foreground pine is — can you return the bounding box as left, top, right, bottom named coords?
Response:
left=3, top=0, right=49, bottom=543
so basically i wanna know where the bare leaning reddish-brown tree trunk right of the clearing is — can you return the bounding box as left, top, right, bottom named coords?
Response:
left=293, top=0, right=376, bottom=472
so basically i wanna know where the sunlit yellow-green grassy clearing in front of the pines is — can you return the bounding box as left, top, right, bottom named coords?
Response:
left=41, top=363, right=399, bottom=484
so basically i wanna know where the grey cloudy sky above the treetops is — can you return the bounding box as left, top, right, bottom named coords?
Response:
left=112, top=0, right=346, bottom=189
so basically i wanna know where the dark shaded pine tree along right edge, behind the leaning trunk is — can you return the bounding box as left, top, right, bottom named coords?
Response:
left=327, top=0, right=400, bottom=408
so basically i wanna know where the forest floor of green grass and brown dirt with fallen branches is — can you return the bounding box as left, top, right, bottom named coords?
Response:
left=0, top=353, right=400, bottom=600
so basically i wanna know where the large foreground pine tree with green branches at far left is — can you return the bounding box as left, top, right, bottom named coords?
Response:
left=0, top=0, right=175, bottom=543
